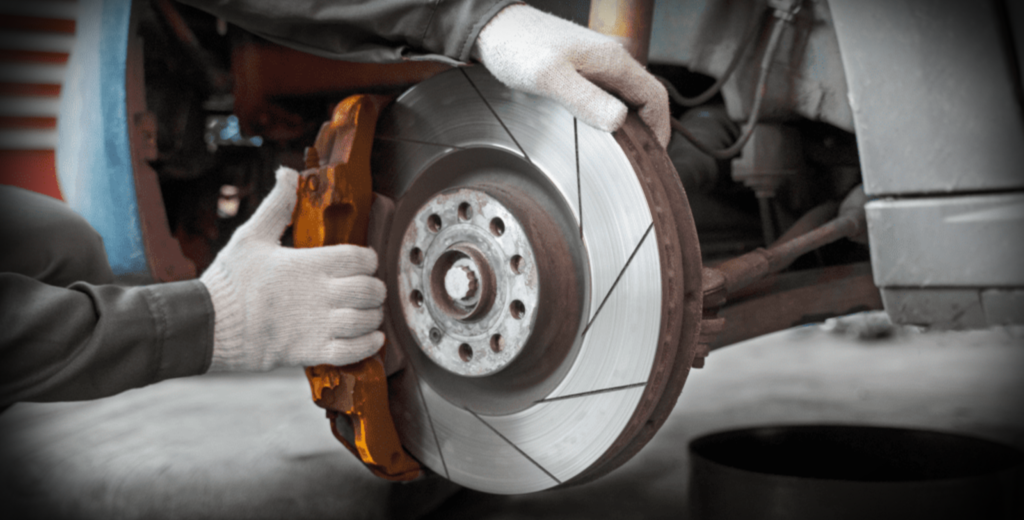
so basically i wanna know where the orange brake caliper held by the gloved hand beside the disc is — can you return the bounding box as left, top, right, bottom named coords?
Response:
left=293, top=95, right=421, bottom=481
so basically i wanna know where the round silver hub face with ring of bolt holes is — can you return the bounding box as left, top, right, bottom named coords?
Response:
left=398, top=188, right=540, bottom=377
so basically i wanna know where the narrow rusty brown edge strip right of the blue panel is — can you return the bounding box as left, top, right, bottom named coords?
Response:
left=125, top=12, right=196, bottom=281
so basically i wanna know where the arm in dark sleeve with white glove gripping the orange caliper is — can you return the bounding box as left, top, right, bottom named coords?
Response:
left=0, top=168, right=385, bottom=409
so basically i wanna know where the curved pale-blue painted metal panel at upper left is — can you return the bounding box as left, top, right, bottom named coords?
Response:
left=56, top=0, right=148, bottom=276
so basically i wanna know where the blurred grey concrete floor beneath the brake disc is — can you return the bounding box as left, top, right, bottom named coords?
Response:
left=0, top=313, right=1024, bottom=519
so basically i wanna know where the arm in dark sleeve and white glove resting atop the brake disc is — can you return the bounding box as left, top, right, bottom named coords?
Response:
left=180, top=0, right=672, bottom=146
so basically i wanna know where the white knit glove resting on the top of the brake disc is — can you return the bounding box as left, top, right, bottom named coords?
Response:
left=472, top=4, right=672, bottom=146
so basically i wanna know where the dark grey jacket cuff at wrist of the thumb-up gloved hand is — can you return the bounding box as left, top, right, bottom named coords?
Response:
left=140, top=279, right=214, bottom=383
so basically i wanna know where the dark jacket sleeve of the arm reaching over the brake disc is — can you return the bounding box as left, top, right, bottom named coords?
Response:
left=179, top=0, right=520, bottom=62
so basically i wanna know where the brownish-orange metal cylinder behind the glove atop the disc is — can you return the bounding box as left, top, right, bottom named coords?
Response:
left=589, top=0, right=654, bottom=64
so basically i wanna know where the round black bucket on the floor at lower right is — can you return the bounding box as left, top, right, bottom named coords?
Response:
left=689, top=425, right=1024, bottom=520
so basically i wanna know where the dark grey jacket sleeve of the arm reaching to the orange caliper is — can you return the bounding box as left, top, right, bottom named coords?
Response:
left=0, top=272, right=213, bottom=409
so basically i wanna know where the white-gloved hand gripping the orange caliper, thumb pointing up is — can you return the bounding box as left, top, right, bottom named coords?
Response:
left=200, top=167, right=385, bottom=372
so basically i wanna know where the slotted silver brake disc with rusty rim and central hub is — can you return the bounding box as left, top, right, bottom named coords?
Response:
left=374, top=68, right=701, bottom=494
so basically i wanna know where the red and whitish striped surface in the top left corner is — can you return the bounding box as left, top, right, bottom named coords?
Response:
left=0, top=0, right=78, bottom=199
